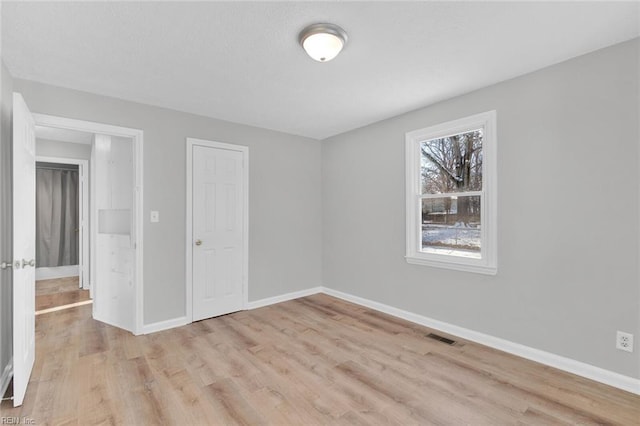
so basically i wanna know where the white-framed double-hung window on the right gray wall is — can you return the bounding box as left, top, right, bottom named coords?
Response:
left=406, top=111, right=497, bottom=274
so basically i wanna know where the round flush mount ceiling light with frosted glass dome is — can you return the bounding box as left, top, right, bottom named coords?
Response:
left=298, top=24, right=347, bottom=62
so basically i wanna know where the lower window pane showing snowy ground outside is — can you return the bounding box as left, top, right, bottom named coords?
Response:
left=421, top=195, right=481, bottom=259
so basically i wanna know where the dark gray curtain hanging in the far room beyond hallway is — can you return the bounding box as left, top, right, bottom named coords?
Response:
left=36, top=168, right=79, bottom=267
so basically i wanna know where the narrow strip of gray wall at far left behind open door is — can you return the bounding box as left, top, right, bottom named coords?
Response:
left=0, top=63, right=13, bottom=397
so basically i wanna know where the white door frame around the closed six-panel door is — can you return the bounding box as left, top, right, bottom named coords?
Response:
left=185, top=138, right=249, bottom=322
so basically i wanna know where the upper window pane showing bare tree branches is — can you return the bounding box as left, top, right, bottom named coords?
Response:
left=420, top=129, right=482, bottom=194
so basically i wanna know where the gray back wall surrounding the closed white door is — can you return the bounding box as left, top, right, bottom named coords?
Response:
left=14, top=79, right=322, bottom=324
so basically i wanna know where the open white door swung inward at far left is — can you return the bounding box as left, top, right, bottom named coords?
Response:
left=13, top=93, right=36, bottom=406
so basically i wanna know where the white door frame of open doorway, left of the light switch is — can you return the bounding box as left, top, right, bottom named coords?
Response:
left=33, top=114, right=144, bottom=335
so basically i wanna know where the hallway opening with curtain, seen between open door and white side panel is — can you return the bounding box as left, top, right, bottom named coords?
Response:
left=35, top=155, right=92, bottom=315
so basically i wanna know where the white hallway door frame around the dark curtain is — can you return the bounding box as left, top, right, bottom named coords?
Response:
left=36, top=155, right=91, bottom=290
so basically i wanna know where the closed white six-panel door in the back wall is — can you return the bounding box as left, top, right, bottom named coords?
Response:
left=187, top=139, right=247, bottom=321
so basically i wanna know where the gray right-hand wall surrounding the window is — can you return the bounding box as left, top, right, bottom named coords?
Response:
left=322, top=39, right=640, bottom=377
